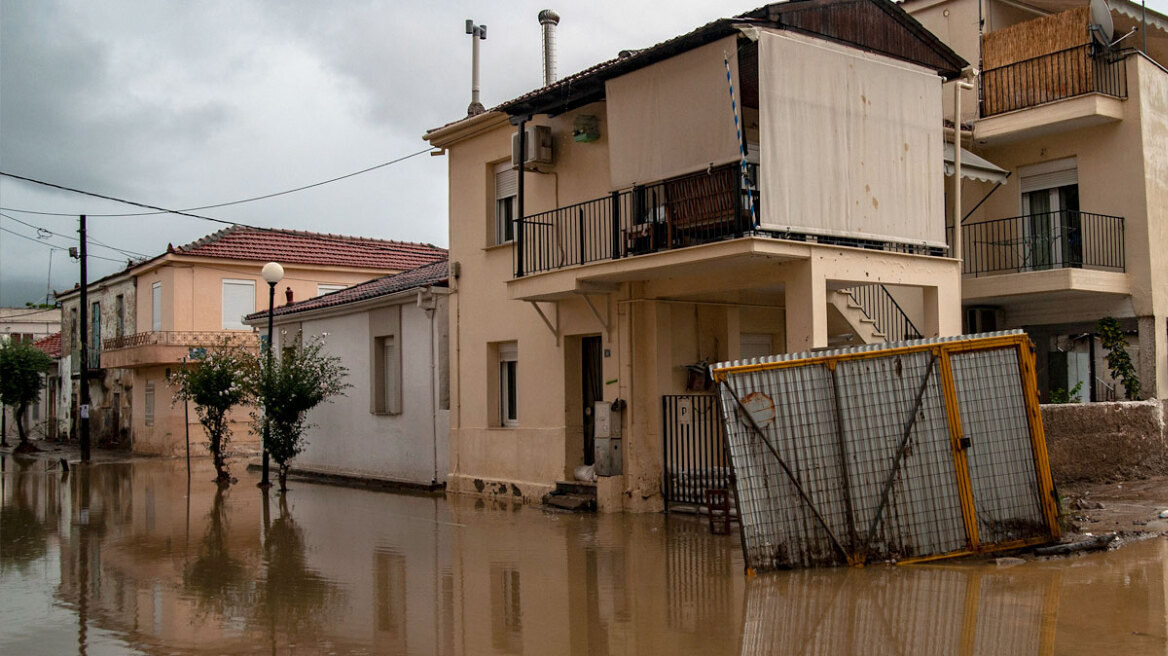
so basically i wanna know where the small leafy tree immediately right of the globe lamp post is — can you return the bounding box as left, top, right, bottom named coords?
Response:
left=249, top=337, right=350, bottom=491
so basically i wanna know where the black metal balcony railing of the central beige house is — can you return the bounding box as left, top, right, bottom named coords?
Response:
left=514, top=163, right=759, bottom=277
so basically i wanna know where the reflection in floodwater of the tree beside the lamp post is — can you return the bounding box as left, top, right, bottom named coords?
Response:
left=252, top=490, right=345, bottom=654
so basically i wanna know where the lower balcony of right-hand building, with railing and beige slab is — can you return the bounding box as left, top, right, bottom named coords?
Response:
left=961, top=210, right=1128, bottom=302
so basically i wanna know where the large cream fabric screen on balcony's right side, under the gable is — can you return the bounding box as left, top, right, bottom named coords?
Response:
left=759, top=32, right=945, bottom=246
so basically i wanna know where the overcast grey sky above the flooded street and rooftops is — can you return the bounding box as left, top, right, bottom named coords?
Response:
left=0, top=0, right=1168, bottom=306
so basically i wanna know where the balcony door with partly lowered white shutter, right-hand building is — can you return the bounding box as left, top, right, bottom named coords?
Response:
left=1020, top=158, right=1083, bottom=271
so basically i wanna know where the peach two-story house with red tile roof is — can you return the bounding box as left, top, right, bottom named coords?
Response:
left=65, top=226, right=446, bottom=455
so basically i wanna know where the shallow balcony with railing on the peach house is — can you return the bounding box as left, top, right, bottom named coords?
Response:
left=102, top=330, right=259, bottom=369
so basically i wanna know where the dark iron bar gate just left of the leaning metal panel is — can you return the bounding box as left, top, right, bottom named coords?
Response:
left=661, top=395, right=730, bottom=510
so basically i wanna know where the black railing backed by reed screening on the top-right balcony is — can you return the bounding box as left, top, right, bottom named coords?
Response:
left=981, top=43, right=1127, bottom=117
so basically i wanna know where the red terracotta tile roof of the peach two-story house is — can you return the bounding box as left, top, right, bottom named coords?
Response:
left=167, top=225, right=446, bottom=271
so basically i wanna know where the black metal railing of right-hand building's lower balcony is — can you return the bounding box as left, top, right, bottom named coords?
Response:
left=961, top=210, right=1126, bottom=275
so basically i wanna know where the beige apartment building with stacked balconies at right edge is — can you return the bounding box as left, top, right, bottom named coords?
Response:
left=902, top=0, right=1168, bottom=400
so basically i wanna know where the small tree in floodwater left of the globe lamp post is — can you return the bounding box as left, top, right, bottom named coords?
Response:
left=171, top=342, right=252, bottom=486
